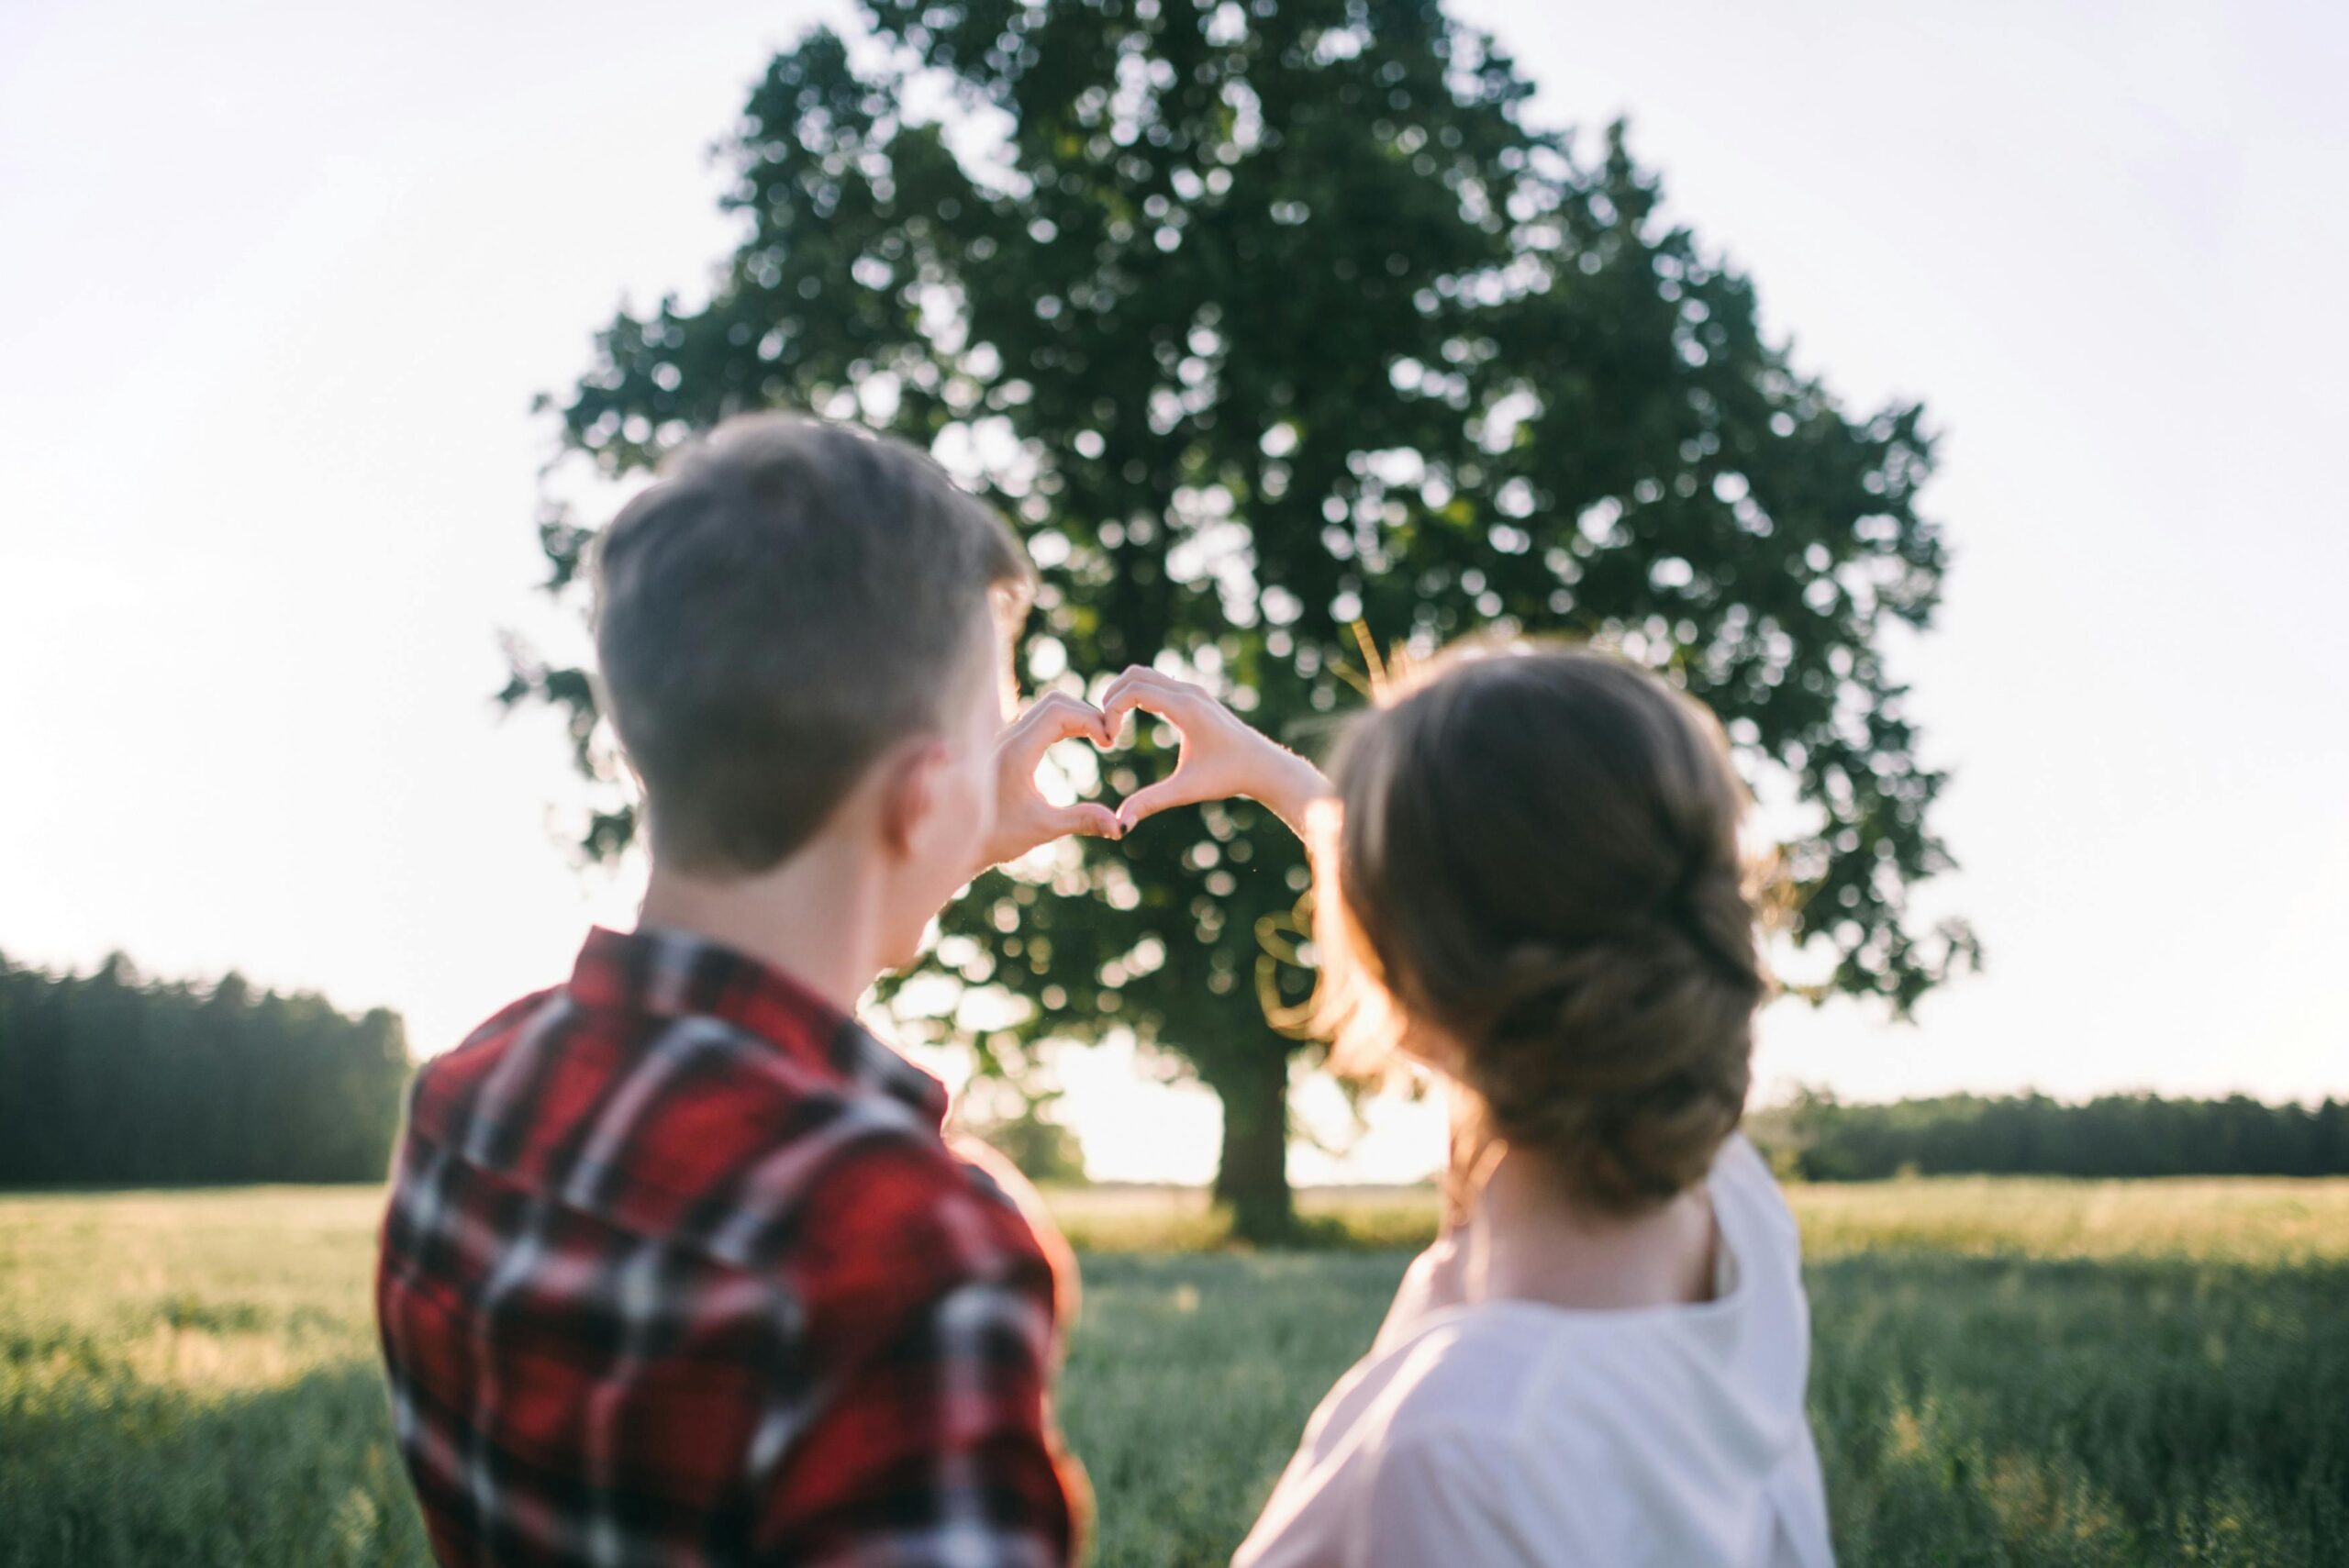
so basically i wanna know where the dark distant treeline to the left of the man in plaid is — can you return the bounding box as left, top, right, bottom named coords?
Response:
left=0, top=955, right=408, bottom=1185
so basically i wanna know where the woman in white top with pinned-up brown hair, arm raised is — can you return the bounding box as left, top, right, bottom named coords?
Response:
left=1102, top=648, right=1832, bottom=1568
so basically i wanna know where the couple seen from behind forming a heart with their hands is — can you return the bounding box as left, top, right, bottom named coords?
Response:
left=376, top=416, right=1830, bottom=1568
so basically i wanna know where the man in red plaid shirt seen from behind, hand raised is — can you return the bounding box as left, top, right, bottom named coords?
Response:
left=378, top=416, right=1120, bottom=1568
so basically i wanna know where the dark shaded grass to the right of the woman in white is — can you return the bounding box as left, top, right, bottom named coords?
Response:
left=1809, top=1253, right=2349, bottom=1568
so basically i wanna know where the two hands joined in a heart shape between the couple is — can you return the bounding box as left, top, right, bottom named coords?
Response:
left=989, top=664, right=1330, bottom=863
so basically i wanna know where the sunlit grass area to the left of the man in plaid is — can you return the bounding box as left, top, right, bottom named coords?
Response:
left=0, top=1188, right=429, bottom=1568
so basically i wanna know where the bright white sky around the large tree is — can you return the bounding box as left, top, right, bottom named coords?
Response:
left=0, top=0, right=2349, bottom=1181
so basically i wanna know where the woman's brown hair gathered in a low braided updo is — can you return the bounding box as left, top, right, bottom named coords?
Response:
left=1318, top=646, right=1766, bottom=1211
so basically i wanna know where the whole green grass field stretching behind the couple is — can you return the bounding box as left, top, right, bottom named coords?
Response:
left=0, top=1181, right=2349, bottom=1568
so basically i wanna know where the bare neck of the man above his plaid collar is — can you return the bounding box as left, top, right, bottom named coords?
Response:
left=637, top=840, right=881, bottom=1014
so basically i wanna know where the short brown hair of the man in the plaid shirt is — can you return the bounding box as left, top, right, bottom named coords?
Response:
left=595, top=413, right=1031, bottom=873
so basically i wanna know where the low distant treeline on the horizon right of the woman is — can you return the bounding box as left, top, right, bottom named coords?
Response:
left=1753, top=1092, right=2349, bottom=1181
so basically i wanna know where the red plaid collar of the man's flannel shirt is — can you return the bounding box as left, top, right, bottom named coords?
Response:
left=571, top=925, right=947, bottom=1127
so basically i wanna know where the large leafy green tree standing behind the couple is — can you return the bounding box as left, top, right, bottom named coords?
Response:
left=507, top=0, right=1971, bottom=1235
